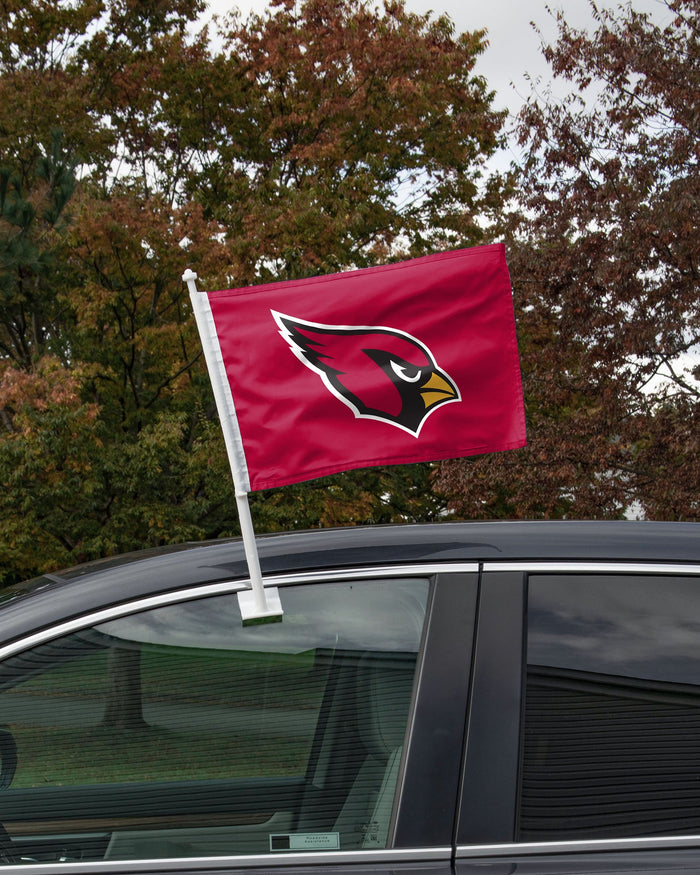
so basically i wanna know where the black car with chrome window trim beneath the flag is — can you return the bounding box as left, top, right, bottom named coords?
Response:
left=0, top=521, right=700, bottom=875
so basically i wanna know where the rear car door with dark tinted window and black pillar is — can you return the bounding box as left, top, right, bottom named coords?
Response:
left=456, top=562, right=700, bottom=875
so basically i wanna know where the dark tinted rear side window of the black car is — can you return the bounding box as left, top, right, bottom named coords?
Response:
left=518, top=575, right=700, bottom=841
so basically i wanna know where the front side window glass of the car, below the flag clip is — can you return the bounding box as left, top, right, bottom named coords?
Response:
left=0, top=579, right=428, bottom=862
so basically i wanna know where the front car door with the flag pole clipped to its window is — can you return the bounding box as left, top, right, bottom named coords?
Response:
left=0, top=567, right=476, bottom=871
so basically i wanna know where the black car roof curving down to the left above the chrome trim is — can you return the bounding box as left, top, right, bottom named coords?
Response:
left=0, top=521, right=700, bottom=641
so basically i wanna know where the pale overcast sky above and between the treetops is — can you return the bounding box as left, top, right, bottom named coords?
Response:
left=209, top=0, right=670, bottom=117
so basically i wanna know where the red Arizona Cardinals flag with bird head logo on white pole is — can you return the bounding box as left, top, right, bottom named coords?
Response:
left=195, top=244, right=525, bottom=490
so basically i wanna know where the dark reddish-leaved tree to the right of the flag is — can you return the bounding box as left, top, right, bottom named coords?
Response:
left=439, top=0, right=700, bottom=519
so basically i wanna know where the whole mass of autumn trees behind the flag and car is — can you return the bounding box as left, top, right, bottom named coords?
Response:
left=0, top=0, right=700, bottom=583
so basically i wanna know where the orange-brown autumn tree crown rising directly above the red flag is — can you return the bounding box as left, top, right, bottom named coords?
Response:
left=194, top=0, right=503, bottom=282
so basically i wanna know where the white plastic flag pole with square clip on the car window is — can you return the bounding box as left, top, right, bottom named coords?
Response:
left=182, top=269, right=282, bottom=625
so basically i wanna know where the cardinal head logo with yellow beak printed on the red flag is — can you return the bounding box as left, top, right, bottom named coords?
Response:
left=271, top=310, right=461, bottom=437
